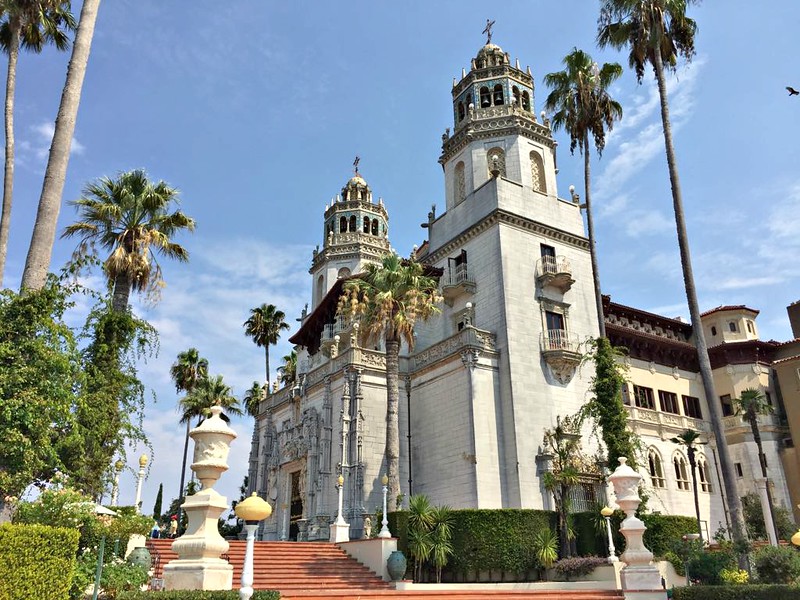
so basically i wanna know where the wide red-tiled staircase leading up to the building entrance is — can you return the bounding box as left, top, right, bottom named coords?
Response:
left=147, top=539, right=623, bottom=600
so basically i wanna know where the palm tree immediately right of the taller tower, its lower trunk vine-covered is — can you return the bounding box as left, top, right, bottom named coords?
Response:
left=544, top=48, right=622, bottom=337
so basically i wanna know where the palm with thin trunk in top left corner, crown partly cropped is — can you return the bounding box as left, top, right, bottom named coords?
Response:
left=0, top=0, right=75, bottom=287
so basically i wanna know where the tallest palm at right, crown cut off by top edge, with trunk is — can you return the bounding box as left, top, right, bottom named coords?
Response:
left=597, top=0, right=745, bottom=541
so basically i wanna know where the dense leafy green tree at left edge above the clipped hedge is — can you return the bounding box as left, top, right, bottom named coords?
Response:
left=0, top=278, right=83, bottom=503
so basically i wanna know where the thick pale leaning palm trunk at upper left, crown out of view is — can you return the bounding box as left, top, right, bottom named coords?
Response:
left=20, top=0, right=100, bottom=290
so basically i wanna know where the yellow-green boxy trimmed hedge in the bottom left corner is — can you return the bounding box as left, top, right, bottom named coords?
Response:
left=0, top=524, right=80, bottom=600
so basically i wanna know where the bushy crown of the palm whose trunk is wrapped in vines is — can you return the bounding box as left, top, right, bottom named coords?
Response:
left=61, top=169, right=195, bottom=312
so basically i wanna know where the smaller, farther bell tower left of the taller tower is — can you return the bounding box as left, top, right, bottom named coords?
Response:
left=309, top=157, right=390, bottom=310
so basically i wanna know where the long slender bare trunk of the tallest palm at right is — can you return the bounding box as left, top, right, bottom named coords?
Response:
left=653, top=52, right=746, bottom=541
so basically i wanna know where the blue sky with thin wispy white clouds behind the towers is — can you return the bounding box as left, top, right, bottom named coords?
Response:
left=5, top=0, right=800, bottom=510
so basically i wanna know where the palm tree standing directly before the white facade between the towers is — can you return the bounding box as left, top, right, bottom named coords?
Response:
left=338, top=254, right=441, bottom=498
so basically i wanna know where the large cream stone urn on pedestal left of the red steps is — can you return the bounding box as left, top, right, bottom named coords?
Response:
left=164, top=406, right=236, bottom=590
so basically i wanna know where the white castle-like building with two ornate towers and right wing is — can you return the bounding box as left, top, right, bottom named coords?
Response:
left=249, top=43, right=789, bottom=540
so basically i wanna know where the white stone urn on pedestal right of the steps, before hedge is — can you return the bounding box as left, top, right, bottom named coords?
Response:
left=609, top=457, right=667, bottom=600
